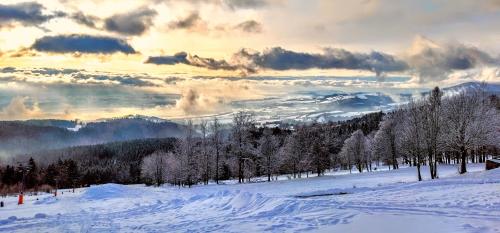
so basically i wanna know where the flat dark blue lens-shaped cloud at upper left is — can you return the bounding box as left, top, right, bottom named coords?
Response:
left=32, top=34, right=136, bottom=54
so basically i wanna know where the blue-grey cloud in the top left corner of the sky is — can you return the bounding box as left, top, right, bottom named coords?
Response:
left=0, top=2, right=65, bottom=27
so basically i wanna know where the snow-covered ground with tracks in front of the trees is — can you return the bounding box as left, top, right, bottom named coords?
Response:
left=0, top=164, right=500, bottom=233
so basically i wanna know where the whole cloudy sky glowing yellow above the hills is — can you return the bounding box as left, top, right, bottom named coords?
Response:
left=0, top=0, right=500, bottom=121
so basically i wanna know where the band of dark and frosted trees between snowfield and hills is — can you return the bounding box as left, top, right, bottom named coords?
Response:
left=0, top=87, right=500, bottom=195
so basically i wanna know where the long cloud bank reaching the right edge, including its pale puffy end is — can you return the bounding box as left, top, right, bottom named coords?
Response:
left=145, top=37, right=500, bottom=79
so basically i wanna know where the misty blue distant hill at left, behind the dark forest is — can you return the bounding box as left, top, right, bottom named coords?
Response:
left=0, top=116, right=185, bottom=156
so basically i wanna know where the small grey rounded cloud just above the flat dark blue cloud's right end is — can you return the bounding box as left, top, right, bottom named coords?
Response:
left=104, top=8, right=157, bottom=35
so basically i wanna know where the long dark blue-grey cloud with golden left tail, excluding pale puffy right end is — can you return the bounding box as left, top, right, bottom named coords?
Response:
left=146, top=47, right=408, bottom=75
